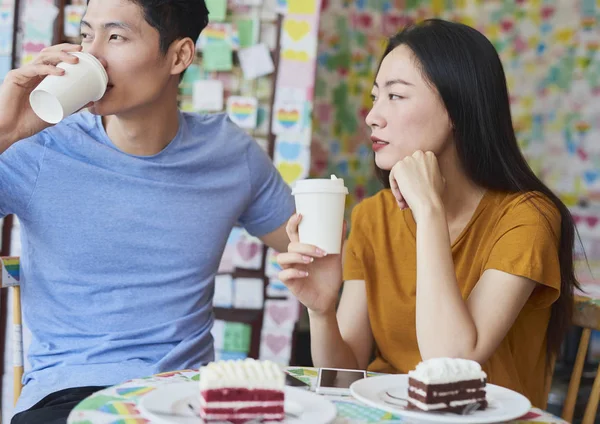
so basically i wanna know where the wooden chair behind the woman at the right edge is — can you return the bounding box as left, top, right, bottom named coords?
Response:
left=562, top=298, right=600, bottom=424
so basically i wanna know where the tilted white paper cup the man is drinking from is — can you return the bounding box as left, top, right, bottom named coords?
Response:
left=29, top=52, right=108, bottom=124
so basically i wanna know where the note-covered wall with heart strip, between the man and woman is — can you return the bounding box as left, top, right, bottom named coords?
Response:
left=189, top=0, right=321, bottom=365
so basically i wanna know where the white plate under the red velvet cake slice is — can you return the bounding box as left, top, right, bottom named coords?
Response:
left=138, top=381, right=337, bottom=424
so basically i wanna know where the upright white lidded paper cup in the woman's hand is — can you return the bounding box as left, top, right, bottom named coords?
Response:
left=292, top=178, right=348, bottom=254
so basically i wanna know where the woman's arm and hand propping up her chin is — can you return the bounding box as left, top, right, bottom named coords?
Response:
left=390, top=151, right=539, bottom=363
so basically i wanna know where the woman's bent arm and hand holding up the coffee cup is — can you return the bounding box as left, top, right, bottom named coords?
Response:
left=277, top=215, right=373, bottom=369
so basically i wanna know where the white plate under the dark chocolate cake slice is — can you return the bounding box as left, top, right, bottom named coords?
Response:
left=350, top=374, right=531, bottom=424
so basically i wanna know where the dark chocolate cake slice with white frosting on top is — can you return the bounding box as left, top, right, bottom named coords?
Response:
left=408, top=358, right=487, bottom=414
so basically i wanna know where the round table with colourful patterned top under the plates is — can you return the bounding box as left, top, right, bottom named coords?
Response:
left=67, top=367, right=565, bottom=424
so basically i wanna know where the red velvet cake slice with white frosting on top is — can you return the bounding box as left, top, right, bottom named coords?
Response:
left=200, top=359, right=285, bottom=424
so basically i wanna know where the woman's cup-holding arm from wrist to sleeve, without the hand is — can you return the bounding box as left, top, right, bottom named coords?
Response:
left=309, top=280, right=373, bottom=369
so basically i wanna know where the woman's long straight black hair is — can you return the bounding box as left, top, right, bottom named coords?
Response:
left=376, top=19, right=579, bottom=355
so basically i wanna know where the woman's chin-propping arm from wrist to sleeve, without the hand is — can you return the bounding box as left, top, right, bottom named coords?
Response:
left=416, top=205, right=536, bottom=363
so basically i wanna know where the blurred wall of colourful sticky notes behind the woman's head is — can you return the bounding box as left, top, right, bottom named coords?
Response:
left=311, top=0, right=600, bottom=279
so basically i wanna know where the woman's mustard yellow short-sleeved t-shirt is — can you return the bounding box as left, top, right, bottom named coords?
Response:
left=344, top=190, right=561, bottom=408
